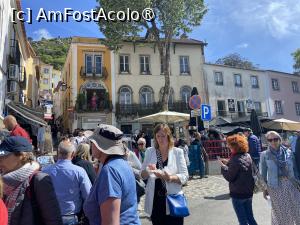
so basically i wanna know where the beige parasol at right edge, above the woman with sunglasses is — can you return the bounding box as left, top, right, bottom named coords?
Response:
left=262, top=118, right=300, bottom=131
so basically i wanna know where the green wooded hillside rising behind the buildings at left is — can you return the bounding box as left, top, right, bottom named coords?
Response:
left=28, top=38, right=72, bottom=70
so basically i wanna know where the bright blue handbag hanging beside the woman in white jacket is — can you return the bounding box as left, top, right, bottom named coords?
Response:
left=167, top=194, right=190, bottom=217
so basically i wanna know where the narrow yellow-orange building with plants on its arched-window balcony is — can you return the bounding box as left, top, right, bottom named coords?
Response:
left=60, top=37, right=114, bottom=131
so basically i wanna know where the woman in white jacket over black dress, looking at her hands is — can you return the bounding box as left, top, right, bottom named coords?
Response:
left=141, top=124, right=189, bottom=225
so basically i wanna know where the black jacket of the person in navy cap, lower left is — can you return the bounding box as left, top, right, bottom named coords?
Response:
left=10, top=172, right=63, bottom=225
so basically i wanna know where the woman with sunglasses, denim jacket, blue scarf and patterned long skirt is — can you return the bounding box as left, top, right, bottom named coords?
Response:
left=260, top=131, right=300, bottom=225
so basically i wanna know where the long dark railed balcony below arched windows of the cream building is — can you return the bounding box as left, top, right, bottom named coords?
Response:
left=116, top=101, right=190, bottom=118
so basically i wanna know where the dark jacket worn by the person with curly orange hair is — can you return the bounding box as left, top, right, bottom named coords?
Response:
left=221, top=153, right=254, bottom=199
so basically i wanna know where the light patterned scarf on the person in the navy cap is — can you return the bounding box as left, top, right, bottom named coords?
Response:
left=2, top=162, right=39, bottom=224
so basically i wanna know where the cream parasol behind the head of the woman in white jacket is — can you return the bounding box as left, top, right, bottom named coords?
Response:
left=135, top=111, right=190, bottom=123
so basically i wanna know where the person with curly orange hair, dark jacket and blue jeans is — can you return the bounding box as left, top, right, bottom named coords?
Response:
left=218, top=134, right=257, bottom=225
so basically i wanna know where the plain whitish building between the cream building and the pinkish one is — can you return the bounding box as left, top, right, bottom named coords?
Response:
left=203, top=63, right=269, bottom=120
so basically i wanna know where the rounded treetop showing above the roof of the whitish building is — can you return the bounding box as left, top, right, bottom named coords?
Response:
left=216, top=53, right=258, bottom=69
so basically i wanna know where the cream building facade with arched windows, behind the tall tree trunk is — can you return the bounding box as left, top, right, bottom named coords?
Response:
left=114, top=39, right=206, bottom=134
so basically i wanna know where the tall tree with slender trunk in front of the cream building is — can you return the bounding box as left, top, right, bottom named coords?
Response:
left=97, top=0, right=207, bottom=110
